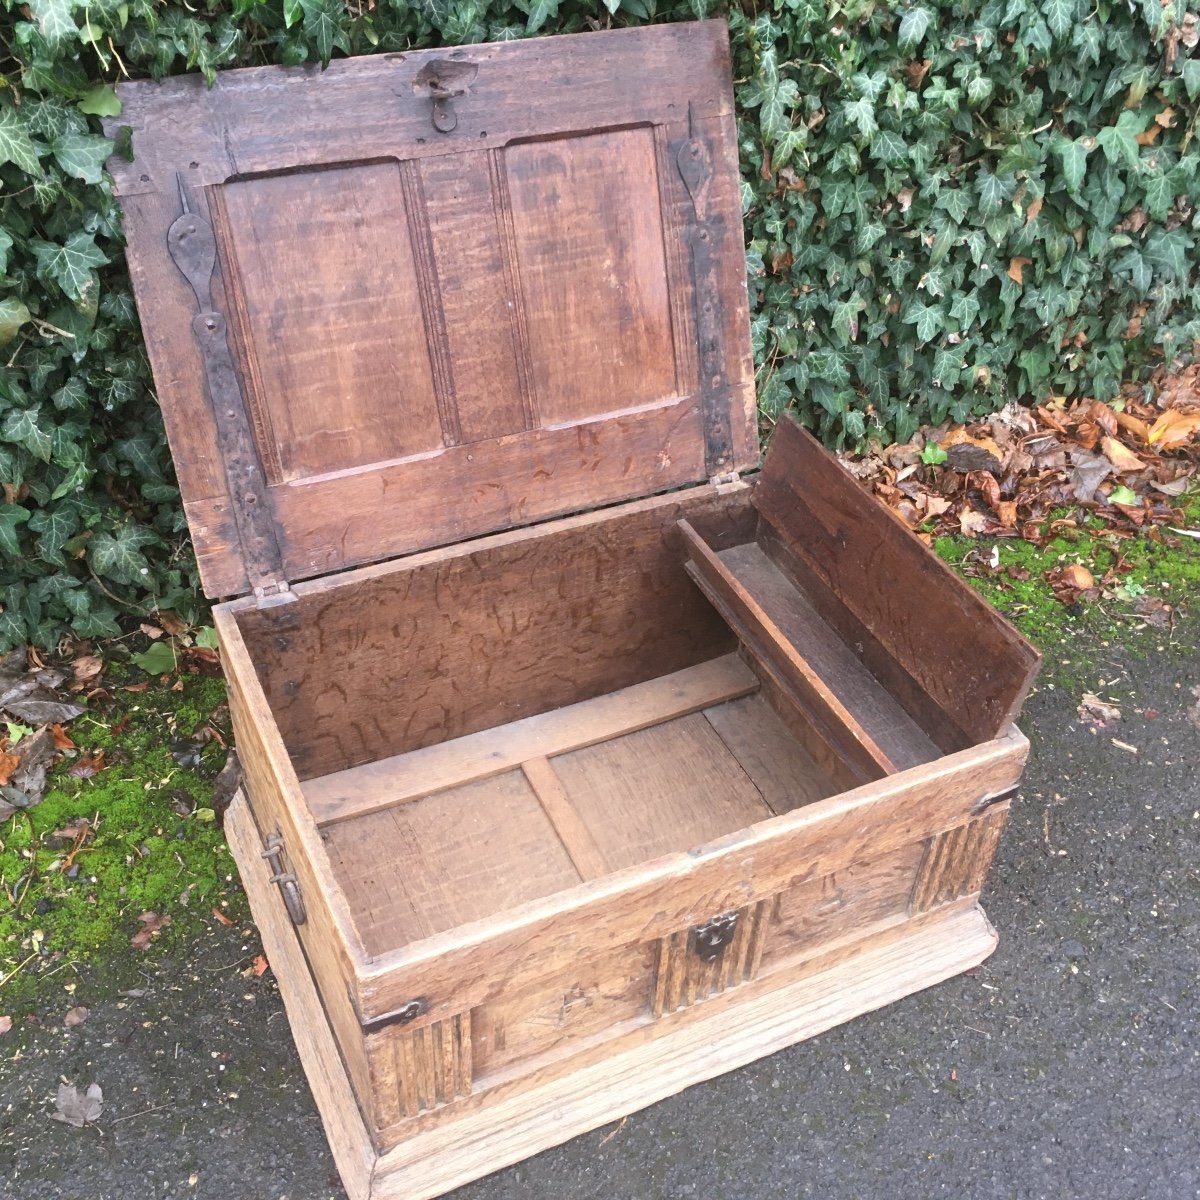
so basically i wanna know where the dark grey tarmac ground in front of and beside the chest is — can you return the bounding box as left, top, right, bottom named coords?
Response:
left=0, top=635, right=1200, bottom=1200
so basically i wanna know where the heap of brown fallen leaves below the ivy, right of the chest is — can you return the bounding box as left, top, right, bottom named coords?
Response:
left=844, top=368, right=1200, bottom=604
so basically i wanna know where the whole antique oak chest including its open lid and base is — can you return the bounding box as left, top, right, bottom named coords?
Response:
left=110, top=22, right=1037, bottom=1200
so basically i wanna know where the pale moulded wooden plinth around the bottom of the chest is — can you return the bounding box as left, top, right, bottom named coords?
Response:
left=226, top=793, right=997, bottom=1200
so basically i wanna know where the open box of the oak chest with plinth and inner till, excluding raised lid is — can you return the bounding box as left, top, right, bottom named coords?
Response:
left=217, top=434, right=1032, bottom=1196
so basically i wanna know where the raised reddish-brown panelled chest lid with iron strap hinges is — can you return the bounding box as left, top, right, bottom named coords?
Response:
left=108, top=22, right=758, bottom=596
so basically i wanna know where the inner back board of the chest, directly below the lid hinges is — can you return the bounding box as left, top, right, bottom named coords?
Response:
left=229, top=487, right=755, bottom=779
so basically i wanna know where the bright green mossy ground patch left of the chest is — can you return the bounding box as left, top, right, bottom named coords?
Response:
left=0, top=667, right=246, bottom=1018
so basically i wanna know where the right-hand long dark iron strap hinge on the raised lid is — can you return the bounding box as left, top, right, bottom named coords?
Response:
left=676, top=104, right=733, bottom=476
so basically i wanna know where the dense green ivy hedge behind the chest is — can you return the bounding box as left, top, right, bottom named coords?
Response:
left=0, top=0, right=1200, bottom=646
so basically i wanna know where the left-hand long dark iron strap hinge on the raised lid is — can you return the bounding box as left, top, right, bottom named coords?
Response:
left=167, top=178, right=283, bottom=589
